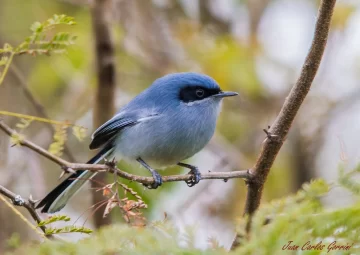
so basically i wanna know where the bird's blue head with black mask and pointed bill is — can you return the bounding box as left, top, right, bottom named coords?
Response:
left=151, top=72, right=238, bottom=106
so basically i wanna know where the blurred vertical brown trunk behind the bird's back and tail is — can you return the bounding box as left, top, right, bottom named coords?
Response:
left=91, top=0, right=116, bottom=228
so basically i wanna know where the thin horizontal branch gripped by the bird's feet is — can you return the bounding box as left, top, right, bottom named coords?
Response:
left=0, top=119, right=252, bottom=185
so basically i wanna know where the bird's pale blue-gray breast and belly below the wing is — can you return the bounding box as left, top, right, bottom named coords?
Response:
left=116, top=103, right=217, bottom=167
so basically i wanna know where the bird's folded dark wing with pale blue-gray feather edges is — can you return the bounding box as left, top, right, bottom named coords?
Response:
left=89, top=115, right=138, bottom=150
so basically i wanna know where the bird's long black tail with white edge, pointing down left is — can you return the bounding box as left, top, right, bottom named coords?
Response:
left=36, top=146, right=113, bottom=213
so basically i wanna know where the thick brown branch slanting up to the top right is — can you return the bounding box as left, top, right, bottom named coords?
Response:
left=232, top=0, right=336, bottom=249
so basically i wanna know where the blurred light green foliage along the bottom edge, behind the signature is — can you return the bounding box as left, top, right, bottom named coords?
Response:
left=9, top=176, right=360, bottom=255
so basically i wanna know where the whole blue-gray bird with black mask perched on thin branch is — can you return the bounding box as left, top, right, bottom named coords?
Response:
left=37, top=73, right=237, bottom=213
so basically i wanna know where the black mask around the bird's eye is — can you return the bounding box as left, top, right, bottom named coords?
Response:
left=179, top=86, right=220, bottom=103
